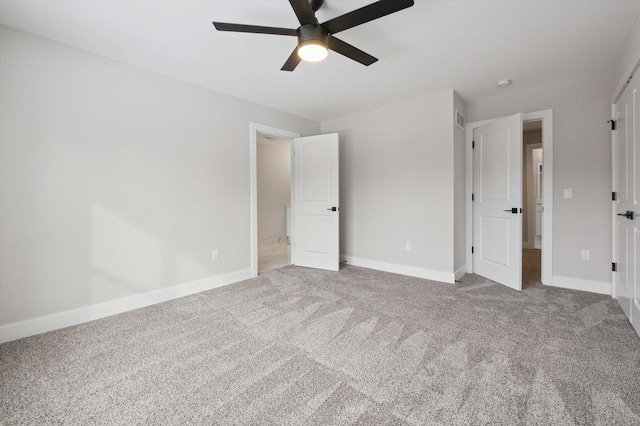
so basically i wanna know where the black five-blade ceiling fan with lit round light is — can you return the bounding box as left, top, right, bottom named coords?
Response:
left=213, top=0, right=413, bottom=71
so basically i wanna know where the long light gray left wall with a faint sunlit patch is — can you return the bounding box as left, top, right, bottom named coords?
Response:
left=0, top=27, right=320, bottom=325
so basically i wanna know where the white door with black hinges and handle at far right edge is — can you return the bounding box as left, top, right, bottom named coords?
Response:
left=613, top=75, right=640, bottom=335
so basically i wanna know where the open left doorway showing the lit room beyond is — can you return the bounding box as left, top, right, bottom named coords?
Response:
left=256, top=133, right=291, bottom=273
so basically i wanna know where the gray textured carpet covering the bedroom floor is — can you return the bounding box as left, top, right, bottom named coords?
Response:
left=0, top=266, right=640, bottom=425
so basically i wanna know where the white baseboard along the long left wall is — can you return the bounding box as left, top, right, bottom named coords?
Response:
left=0, top=269, right=252, bottom=343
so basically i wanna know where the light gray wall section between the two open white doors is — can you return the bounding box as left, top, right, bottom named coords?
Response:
left=322, top=90, right=464, bottom=272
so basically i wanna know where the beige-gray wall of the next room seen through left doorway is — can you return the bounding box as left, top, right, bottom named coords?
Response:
left=256, top=138, right=291, bottom=240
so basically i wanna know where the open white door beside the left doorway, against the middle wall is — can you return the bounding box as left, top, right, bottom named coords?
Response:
left=293, top=133, right=340, bottom=271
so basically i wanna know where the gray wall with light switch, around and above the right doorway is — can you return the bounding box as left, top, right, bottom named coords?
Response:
left=467, top=74, right=613, bottom=282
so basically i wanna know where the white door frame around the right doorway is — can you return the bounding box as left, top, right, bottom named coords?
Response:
left=465, top=109, right=553, bottom=285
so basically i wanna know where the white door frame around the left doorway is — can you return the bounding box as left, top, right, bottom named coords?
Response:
left=249, top=122, right=300, bottom=278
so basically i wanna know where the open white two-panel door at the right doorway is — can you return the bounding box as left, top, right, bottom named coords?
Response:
left=473, top=114, right=522, bottom=290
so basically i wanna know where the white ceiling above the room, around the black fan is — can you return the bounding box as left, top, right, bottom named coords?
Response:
left=0, top=0, right=640, bottom=121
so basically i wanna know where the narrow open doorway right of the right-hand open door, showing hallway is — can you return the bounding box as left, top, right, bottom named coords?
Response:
left=522, top=120, right=543, bottom=289
